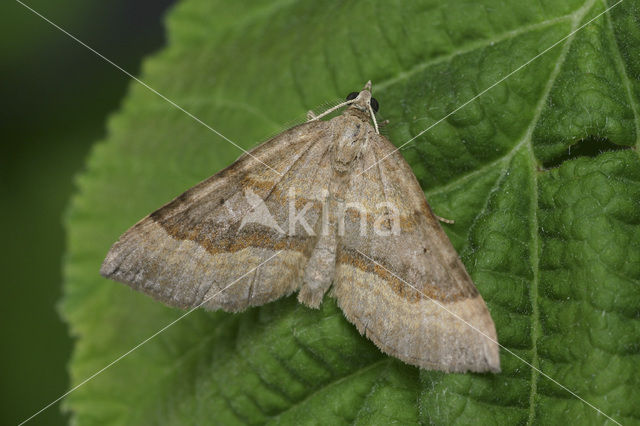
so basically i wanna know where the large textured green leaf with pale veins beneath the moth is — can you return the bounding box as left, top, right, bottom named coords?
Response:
left=62, top=0, right=640, bottom=425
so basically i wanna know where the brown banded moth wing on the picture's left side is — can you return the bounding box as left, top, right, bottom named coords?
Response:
left=100, top=121, right=330, bottom=311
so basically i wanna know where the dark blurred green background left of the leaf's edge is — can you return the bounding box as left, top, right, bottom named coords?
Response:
left=0, top=0, right=174, bottom=425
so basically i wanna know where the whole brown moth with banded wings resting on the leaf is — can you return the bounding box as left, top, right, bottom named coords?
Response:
left=100, top=82, right=500, bottom=372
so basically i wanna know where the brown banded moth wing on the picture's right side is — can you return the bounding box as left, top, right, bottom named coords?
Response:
left=332, top=131, right=500, bottom=372
